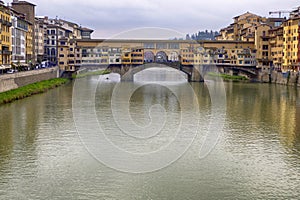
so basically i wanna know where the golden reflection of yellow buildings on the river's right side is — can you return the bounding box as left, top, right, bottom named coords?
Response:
left=227, top=83, right=299, bottom=149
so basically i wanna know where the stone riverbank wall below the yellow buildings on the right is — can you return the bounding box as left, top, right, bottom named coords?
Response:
left=258, top=71, right=300, bottom=87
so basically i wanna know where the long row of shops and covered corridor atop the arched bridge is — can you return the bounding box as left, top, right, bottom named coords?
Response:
left=59, top=39, right=256, bottom=71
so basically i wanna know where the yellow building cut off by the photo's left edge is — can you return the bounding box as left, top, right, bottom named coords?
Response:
left=0, top=3, right=12, bottom=69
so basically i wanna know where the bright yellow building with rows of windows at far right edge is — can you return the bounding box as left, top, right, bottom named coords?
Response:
left=283, top=17, right=300, bottom=71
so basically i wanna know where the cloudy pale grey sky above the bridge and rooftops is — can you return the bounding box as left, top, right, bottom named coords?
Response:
left=5, top=0, right=300, bottom=38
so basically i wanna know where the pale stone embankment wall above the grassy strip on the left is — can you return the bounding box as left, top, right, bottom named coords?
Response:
left=0, top=67, right=59, bottom=93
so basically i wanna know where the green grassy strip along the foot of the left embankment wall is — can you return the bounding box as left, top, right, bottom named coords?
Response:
left=0, top=78, right=69, bottom=105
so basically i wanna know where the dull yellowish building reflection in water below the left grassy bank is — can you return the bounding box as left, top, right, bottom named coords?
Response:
left=0, top=92, right=45, bottom=172
